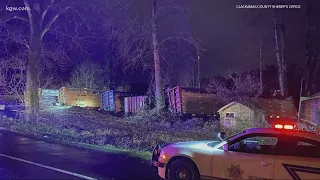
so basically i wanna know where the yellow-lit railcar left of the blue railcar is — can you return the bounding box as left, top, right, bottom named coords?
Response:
left=58, top=87, right=101, bottom=107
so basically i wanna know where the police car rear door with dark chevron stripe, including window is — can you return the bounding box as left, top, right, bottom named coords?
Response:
left=274, top=135, right=320, bottom=180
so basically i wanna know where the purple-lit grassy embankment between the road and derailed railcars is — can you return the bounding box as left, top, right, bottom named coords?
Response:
left=0, top=107, right=218, bottom=159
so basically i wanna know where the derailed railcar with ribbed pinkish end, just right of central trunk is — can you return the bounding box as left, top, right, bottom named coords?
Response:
left=168, top=86, right=223, bottom=120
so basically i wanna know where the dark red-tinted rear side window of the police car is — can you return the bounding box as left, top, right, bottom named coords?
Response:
left=276, top=136, right=320, bottom=158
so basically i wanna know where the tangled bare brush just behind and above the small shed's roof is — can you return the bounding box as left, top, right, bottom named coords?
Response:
left=206, top=75, right=263, bottom=103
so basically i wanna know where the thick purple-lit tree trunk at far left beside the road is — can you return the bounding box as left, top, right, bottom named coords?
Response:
left=26, top=9, right=42, bottom=121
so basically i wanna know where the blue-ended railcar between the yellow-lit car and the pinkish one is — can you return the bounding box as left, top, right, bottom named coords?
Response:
left=101, top=90, right=131, bottom=113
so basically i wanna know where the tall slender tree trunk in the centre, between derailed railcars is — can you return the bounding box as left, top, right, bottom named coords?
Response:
left=152, top=0, right=163, bottom=111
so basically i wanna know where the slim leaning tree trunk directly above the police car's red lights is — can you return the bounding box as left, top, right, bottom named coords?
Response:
left=273, top=10, right=284, bottom=96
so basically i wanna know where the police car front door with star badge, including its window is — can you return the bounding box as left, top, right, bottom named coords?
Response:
left=212, top=134, right=277, bottom=180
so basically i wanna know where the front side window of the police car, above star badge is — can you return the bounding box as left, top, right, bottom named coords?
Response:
left=229, top=135, right=278, bottom=154
